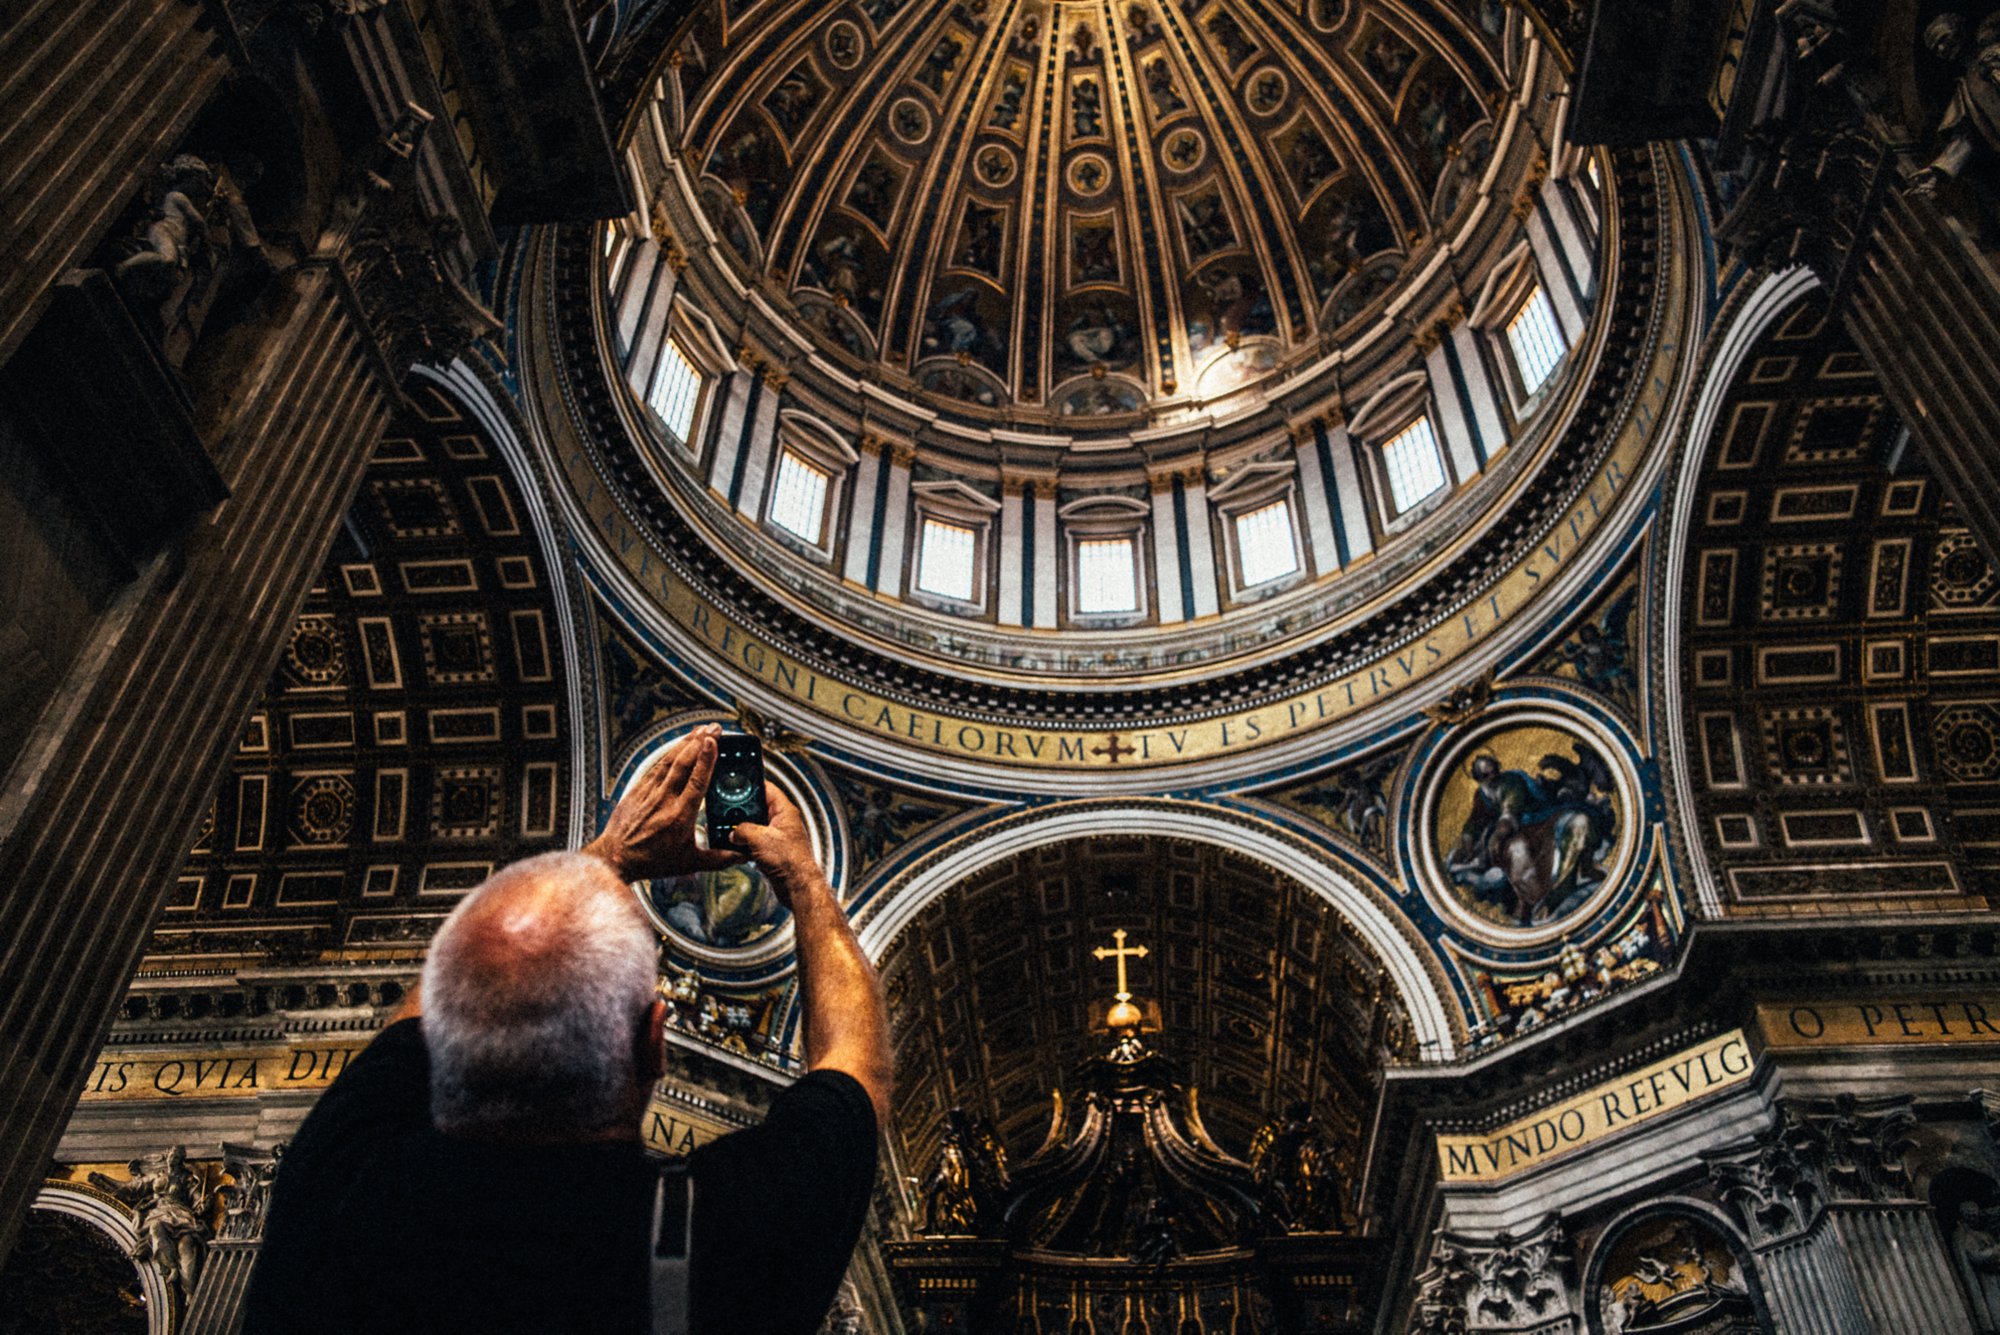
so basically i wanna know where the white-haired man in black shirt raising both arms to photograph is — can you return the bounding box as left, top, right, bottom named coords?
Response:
left=244, top=727, right=890, bottom=1335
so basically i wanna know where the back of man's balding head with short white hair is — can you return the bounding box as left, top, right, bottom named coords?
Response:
left=424, top=853, right=658, bottom=1137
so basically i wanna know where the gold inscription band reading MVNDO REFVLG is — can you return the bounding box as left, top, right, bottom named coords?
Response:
left=1438, top=1029, right=1752, bottom=1181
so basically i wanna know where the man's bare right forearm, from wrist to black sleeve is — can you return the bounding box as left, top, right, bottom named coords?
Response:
left=792, top=875, right=894, bottom=1125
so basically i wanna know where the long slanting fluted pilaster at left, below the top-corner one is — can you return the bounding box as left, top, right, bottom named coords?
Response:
left=0, top=264, right=388, bottom=1255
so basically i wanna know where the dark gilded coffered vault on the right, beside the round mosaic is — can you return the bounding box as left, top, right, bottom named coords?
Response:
left=1678, top=294, right=2000, bottom=913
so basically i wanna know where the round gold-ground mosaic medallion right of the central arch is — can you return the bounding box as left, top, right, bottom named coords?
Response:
left=1412, top=709, right=1642, bottom=945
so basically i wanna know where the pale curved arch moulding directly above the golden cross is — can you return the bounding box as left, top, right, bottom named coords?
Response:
left=856, top=799, right=1462, bottom=1061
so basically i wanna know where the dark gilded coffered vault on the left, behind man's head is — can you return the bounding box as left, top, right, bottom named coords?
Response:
left=144, top=375, right=572, bottom=973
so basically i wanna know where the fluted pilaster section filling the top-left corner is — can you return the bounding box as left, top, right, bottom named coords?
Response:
left=0, top=0, right=228, bottom=362
